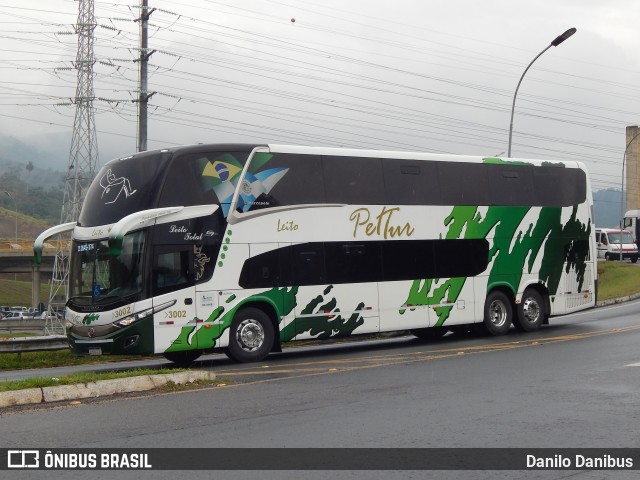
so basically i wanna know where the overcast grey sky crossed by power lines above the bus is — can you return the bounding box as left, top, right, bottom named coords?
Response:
left=0, top=0, right=640, bottom=193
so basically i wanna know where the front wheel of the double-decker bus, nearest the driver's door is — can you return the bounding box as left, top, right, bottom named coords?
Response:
left=225, top=307, right=275, bottom=363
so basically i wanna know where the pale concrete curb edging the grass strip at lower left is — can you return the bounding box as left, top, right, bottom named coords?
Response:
left=0, top=370, right=216, bottom=408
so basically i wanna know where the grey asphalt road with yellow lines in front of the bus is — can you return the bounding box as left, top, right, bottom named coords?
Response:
left=0, top=301, right=640, bottom=480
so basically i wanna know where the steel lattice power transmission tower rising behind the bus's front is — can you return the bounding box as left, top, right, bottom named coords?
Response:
left=45, top=0, right=98, bottom=335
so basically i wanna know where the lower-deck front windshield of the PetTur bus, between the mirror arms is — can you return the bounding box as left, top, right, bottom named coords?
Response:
left=69, top=231, right=145, bottom=304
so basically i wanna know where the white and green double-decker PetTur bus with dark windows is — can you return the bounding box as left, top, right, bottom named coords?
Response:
left=34, top=144, right=597, bottom=363
